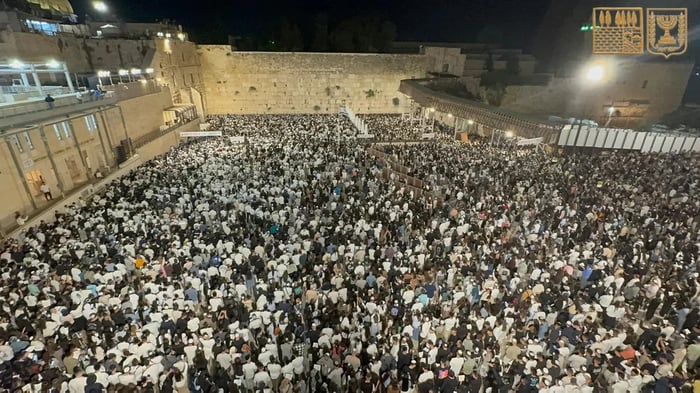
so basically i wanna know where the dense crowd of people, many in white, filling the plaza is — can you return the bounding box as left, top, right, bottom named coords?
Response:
left=0, top=115, right=700, bottom=393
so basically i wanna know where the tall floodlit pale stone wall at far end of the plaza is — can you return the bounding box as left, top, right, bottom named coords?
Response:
left=199, top=45, right=432, bottom=114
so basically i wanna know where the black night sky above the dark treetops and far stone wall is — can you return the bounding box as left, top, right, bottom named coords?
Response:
left=72, top=0, right=552, bottom=48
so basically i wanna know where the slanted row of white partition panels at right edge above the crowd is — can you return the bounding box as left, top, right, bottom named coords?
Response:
left=559, top=125, right=700, bottom=153
